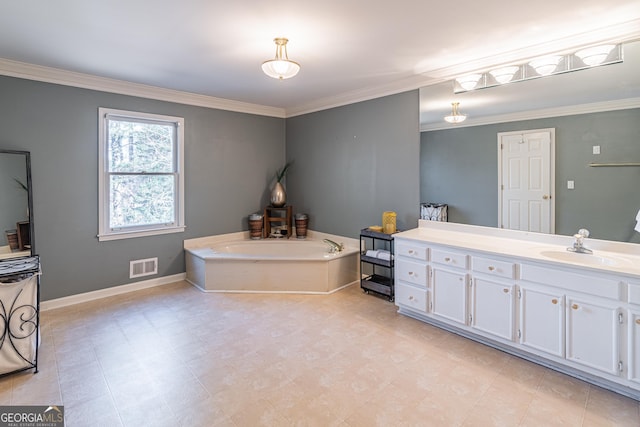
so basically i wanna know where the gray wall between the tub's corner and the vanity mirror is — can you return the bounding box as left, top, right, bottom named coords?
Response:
left=286, top=91, right=420, bottom=237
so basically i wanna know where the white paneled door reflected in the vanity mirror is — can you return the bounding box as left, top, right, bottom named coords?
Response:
left=498, top=129, right=555, bottom=233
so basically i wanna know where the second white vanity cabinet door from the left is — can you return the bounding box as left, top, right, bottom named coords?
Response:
left=471, top=277, right=515, bottom=341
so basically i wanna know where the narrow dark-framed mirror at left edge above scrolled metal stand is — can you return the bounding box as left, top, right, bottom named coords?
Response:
left=0, top=149, right=35, bottom=261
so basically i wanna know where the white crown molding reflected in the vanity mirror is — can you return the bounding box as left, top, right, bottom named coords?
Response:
left=420, top=98, right=640, bottom=132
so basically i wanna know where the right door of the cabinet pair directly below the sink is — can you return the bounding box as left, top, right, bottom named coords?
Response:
left=566, top=296, right=619, bottom=375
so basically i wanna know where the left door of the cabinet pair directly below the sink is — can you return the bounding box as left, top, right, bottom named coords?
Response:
left=520, top=288, right=565, bottom=357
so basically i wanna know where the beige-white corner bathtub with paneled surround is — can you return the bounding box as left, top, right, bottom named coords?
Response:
left=184, top=230, right=360, bottom=294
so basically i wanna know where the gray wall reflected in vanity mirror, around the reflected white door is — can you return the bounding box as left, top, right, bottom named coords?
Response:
left=420, top=109, right=640, bottom=242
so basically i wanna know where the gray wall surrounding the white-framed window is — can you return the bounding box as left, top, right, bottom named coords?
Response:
left=0, top=77, right=285, bottom=300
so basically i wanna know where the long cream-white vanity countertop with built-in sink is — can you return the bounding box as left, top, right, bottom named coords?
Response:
left=394, top=220, right=640, bottom=279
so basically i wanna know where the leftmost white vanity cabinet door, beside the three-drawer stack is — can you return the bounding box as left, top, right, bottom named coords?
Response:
left=431, top=267, right=467, bottom=325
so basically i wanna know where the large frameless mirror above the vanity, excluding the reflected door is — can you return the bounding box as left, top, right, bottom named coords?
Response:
left=420, top=42, right=640, bottom=243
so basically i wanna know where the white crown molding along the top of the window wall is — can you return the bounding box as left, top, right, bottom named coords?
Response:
left=0, top=58, right=285, bottom=118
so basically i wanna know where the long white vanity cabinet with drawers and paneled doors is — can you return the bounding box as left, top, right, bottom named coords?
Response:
left=395, top=221, right=640, bottom=400
